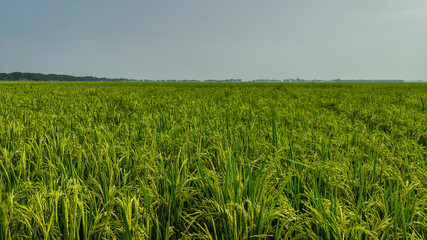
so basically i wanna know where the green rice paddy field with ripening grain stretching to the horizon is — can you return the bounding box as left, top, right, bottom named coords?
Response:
left=0, top=82, right=427, bottom=240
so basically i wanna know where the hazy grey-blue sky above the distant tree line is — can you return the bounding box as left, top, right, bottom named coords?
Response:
left=0, top=0, right=427, bottom=80
